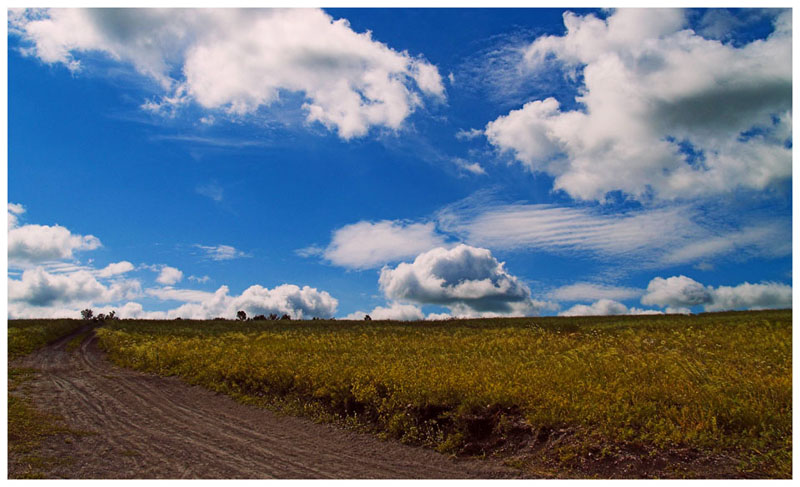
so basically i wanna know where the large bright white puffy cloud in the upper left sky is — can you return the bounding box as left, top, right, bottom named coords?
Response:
left=9, top=9, right=445, bottom=139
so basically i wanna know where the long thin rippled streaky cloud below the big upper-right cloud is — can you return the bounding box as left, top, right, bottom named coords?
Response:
left=436, top=192, right=791, bottom=266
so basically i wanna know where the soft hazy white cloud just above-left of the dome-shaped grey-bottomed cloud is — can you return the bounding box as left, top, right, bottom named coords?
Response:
left=318, top=220, right=445, bottom=269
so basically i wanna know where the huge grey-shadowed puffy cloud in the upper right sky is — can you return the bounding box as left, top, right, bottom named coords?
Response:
left=485, top=9, right=792, bottom=201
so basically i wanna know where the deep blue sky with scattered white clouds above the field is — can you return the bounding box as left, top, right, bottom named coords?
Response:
left=7, top=9, right=792, bottom=319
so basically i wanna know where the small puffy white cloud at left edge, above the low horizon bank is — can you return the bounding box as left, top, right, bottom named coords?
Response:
left=8, top=225, right=101, bottom=267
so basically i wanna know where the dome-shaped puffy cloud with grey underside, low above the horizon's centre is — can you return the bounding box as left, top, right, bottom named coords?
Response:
left=379, top=244, right=545, bottom=315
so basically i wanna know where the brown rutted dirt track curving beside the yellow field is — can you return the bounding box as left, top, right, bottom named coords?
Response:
left=9, top=330, right=516, bottom=478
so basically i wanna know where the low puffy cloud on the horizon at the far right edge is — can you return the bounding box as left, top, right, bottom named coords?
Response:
left=641, top=275, right=792, bottom=312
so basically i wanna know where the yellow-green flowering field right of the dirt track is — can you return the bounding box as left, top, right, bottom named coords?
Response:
left=90, top=310, right=792, bottom=478
